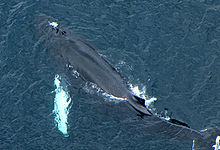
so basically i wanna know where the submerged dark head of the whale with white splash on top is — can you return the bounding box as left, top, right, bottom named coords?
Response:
left=34, top=14, right=68, bottom=71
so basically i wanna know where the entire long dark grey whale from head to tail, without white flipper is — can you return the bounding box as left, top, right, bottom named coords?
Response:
left=36, top=14, right=220, bottom=150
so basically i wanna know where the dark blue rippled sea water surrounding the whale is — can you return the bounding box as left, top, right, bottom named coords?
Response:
left=0, top=0, right=220, bottom=150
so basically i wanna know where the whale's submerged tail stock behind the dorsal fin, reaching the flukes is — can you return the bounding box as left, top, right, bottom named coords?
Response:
left=131, top=96, right=220, bottom=150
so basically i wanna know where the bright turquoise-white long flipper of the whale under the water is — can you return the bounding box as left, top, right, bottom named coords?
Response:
left=53, top=75, right=71, bottom=136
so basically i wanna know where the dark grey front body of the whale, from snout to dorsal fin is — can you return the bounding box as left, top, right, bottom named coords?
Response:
left=35, top=13, right=152, bottom=115
